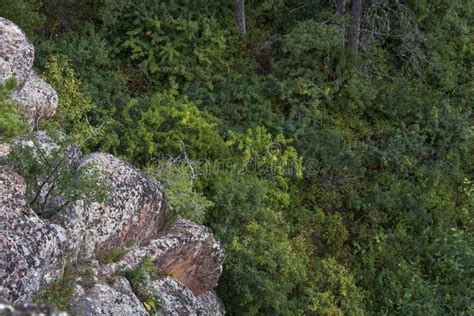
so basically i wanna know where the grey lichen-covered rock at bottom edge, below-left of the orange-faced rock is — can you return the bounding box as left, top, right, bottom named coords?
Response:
left=71, top=277, right=149, bottom=316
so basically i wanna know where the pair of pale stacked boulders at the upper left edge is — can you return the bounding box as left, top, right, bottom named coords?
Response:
left=0, top=17, right=58, bottom=127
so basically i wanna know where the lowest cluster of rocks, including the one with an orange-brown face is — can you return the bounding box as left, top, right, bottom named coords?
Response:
left=69, top=219, right=225, bottom=315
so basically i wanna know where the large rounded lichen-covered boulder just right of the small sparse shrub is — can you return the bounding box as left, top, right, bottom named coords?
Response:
left=55, top=153, right=166, bottom=254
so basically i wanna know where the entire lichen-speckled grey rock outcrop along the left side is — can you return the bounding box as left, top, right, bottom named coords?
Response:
left=0, top=18, right=225, bottom=315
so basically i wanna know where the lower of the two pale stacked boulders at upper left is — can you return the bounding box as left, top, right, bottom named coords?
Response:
left=13, top=71, right=58, bottom=126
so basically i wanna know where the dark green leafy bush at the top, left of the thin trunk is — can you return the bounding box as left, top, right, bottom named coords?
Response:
left=103, top=0, right=236, bottom=91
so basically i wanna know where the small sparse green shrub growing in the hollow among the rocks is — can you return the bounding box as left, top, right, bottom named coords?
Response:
left=7, top=135, right=108, bottom=218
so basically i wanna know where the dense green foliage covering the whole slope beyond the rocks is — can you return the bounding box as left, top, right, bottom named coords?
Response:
left=0, top=0, right=474, bottom=315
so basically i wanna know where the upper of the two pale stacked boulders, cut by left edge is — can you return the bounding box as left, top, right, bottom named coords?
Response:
left=0, top=17, right=34, bottom=90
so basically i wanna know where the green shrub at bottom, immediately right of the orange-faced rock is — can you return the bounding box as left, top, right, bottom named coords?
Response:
left=208, top=176, right=309, bottom=315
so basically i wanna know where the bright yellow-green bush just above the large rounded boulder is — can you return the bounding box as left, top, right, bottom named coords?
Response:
left=102, top=90, right=230, bottom=165
